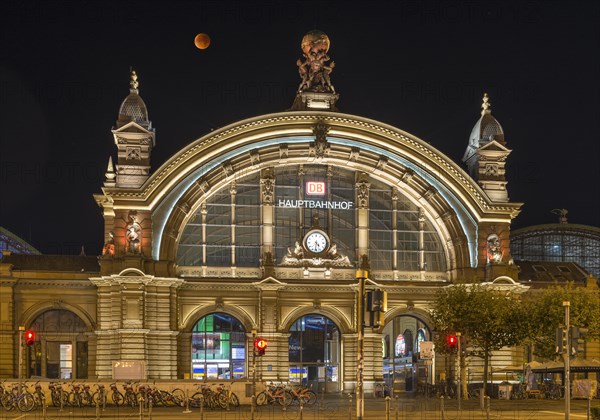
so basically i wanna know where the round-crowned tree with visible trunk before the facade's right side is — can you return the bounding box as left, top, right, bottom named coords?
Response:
left=431, top=285, right=527, bottom=398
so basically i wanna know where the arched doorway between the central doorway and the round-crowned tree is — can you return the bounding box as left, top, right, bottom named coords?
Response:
left=382, top=315, right=432, bottom=392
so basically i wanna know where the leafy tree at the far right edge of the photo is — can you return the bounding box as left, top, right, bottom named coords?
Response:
left=523, top=282, right=600, bottom=359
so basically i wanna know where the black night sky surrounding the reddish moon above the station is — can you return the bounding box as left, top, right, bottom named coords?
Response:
left=0, top=0, right=600, bottom=255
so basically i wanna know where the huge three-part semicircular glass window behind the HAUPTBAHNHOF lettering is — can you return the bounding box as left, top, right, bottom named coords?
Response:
left=177, top=164, right=446, bottom=272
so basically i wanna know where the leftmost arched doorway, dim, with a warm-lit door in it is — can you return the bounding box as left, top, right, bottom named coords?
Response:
left=27, top=309, right=89, bottom=379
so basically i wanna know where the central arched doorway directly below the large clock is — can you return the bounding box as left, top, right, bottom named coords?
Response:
left=289, top=314, right=340, bottom=392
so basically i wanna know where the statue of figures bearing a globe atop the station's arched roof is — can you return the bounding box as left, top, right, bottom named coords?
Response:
left=296, top=30, right=335, bottom=93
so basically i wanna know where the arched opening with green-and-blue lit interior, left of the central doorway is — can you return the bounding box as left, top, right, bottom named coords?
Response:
left=191, top=312, right=247, bottom=380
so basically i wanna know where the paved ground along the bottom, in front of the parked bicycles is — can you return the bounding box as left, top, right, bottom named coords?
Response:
left=0, top=394, right=600, bottom=420
